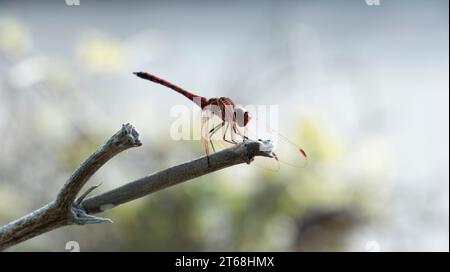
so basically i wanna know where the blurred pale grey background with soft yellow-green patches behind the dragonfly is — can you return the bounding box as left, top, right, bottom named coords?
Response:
left=0, top=0, right=449, bottom=251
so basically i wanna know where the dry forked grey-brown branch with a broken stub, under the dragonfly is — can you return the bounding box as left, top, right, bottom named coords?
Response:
left=0, top=124, right=271, bottom=251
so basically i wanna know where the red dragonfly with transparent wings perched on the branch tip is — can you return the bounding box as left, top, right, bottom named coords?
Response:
left=134, top=72, right=307, bottom=166
